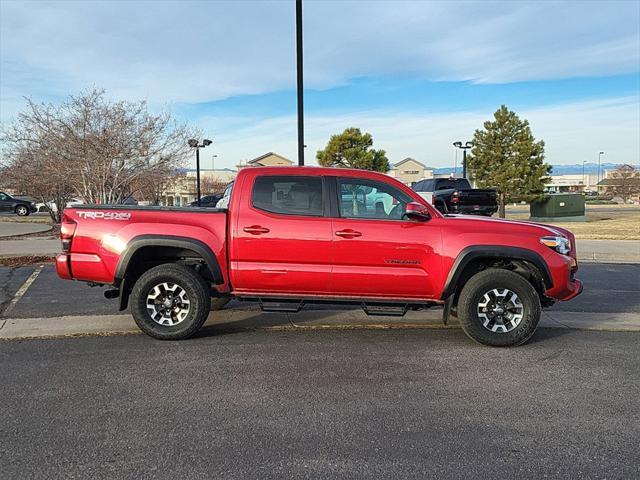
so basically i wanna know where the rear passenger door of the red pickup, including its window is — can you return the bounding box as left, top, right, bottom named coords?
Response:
left=230, top=174, right=332, bottom=295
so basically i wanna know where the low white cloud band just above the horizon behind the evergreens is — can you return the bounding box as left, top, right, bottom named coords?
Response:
left=201, top=98, right=640, bottom=167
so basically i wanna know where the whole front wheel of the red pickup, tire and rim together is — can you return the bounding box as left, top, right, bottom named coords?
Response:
left=457, top=268, right=541, bottom=347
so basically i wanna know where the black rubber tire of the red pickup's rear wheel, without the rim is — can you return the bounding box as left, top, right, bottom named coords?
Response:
left=129, top=263, right=211, bottom=340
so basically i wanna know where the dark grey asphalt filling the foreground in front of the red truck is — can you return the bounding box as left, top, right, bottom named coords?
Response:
left=0, top=329, right=640, bottom=480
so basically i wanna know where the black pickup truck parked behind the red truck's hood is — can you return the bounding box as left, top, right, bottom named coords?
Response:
left=411, top=177, right=498, bottom=217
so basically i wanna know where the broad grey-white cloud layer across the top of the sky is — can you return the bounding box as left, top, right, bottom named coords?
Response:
left=0, top=0, right=640, bottom=109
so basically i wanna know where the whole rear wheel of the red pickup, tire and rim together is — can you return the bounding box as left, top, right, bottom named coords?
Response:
left=130, top=263, right=211, bottom=340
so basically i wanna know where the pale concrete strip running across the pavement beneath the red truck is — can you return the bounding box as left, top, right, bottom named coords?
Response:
left=0, top=309, right=640, bottom=340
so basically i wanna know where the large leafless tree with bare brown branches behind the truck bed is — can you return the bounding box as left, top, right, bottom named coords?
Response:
left=2, top=90, right=194, bottom=220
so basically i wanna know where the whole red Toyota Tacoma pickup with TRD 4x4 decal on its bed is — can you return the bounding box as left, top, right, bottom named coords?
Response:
left=56, top=167, right=582, bottom=346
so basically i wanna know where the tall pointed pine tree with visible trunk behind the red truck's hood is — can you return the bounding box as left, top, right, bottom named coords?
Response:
left=467, top=105, right=551, bottom=218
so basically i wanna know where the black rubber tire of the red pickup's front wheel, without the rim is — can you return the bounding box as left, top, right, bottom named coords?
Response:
left=457, top=268, right=542, bottom=347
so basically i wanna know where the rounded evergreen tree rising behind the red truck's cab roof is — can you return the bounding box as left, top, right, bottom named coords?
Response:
left=316, top=128, right=389, bottom=172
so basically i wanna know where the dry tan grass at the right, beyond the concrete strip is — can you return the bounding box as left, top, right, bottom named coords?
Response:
left=507, top=205, right=640, bottom=240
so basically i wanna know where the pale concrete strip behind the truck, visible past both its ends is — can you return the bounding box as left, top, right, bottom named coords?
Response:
left=0, top=238, right=640, bottom=263
